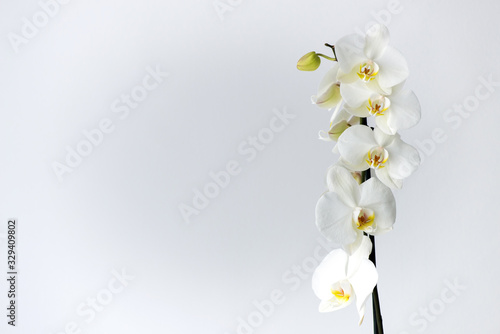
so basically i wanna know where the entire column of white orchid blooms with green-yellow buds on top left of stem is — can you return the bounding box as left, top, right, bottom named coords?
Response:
left=297, top=24, right=420, bottom=332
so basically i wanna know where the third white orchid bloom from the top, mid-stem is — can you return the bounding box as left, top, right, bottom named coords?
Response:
left=337, top=125, right=420, bottom=189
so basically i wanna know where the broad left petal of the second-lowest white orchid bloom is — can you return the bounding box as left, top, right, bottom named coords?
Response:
left=316, top=192, right=361, bottom=245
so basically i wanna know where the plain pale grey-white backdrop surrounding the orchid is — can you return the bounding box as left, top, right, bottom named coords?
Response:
left=0, top=0, right=500, bottom=334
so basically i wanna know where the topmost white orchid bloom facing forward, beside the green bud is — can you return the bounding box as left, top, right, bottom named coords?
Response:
left=335, top=24, right=409, bottom=94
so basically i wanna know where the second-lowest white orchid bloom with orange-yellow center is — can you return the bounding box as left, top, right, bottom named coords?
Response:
left=316, top=165, right=396, bottom=252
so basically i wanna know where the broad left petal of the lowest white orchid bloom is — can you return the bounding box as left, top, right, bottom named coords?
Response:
left=312, top=249, right=348, bottom=300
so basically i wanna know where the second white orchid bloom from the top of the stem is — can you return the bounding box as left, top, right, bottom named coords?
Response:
left=340, top=81, right=420, bottom=135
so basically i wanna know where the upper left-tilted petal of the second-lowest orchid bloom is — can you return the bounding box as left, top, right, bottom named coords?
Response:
left=326, top=165, right=360, bottom=208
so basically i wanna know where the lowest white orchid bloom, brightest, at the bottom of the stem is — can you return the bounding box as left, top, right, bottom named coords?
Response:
left=312, top=236, right=378, bottom=325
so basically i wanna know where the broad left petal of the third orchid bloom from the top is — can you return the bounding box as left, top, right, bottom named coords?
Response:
left=338, top=125, right=377, bottom=171
